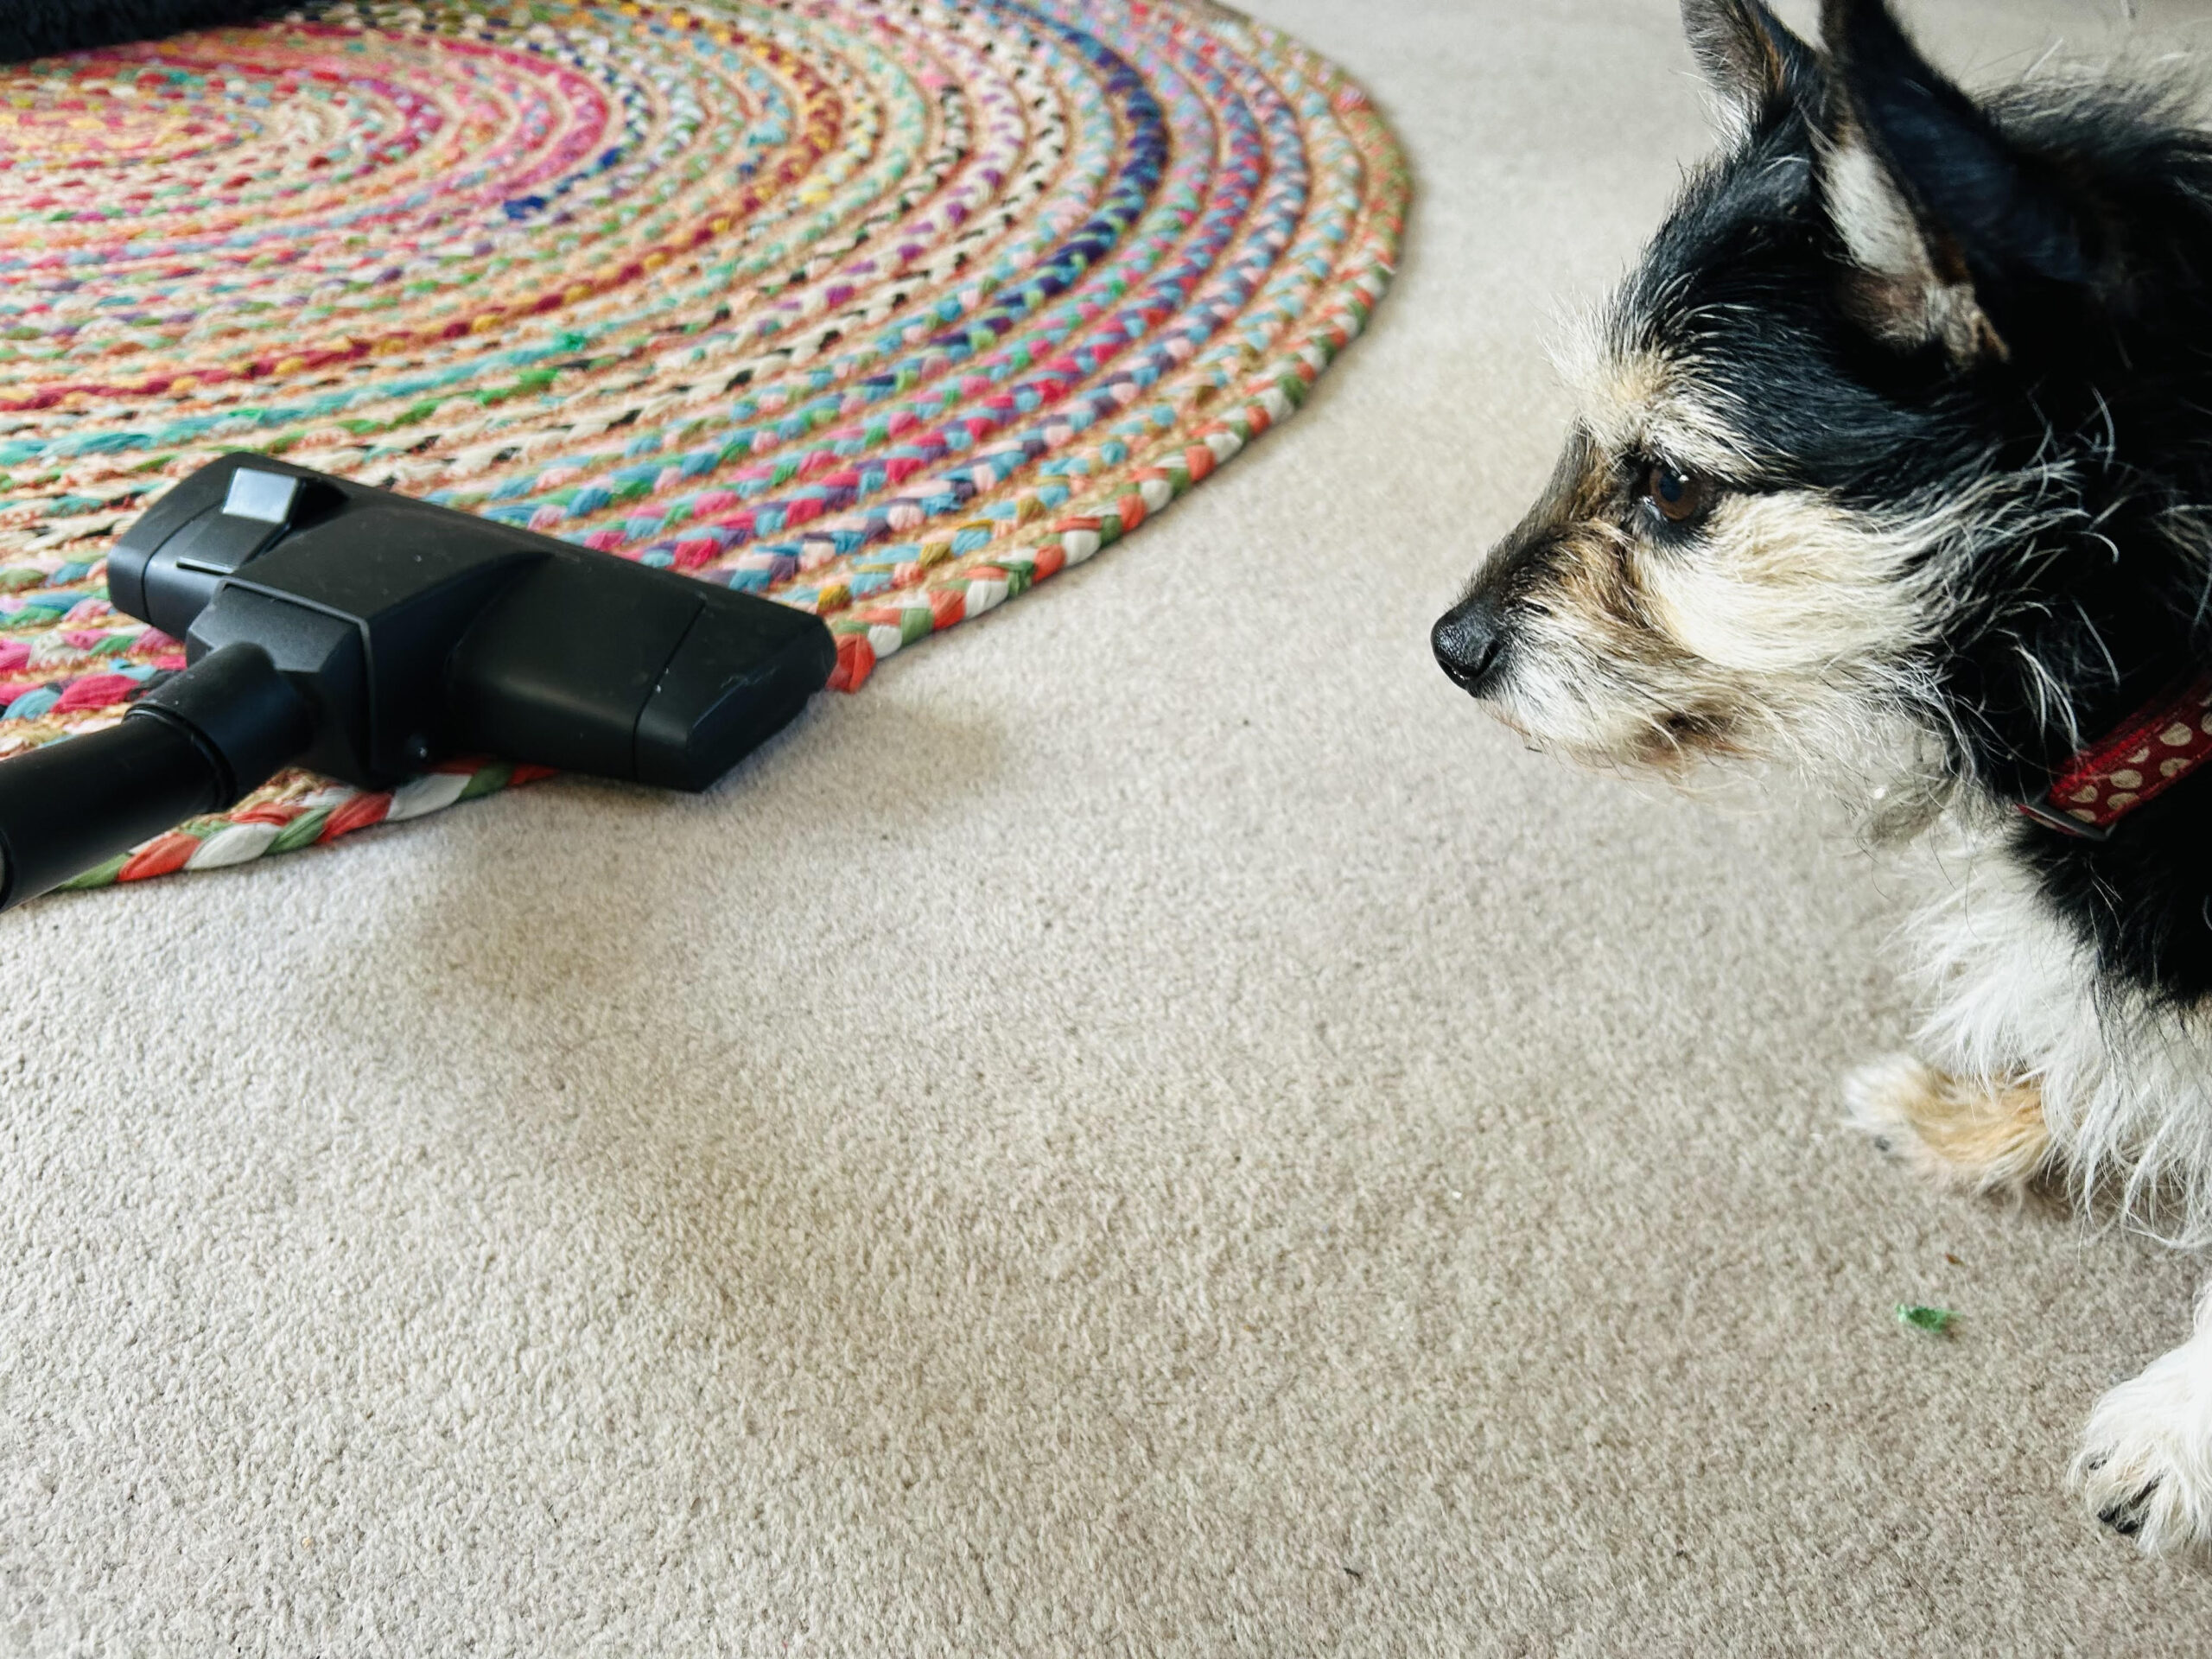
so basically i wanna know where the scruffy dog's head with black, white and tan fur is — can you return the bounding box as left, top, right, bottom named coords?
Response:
left=1433, top=0, right=2177, bottom=791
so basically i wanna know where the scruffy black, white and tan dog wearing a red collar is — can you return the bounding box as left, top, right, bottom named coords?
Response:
left=1431, top=0, right=2212, bottom=1551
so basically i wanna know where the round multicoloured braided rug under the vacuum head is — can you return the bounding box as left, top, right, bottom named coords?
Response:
left=0, top=0, right=1407, bottom=887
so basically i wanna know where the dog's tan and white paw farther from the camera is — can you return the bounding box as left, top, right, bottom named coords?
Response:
left=1842, top=1055, right=2050, bottom=1197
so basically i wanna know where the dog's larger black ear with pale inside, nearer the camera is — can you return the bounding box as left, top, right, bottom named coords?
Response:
left=1821, top=0, right=2090, bottom=367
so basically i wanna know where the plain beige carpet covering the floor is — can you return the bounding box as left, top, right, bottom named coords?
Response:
left=0, top=0, right=2212, bottom=1656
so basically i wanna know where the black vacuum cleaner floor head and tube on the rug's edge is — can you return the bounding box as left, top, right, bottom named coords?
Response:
left=0, top=454, right=836, bottom=909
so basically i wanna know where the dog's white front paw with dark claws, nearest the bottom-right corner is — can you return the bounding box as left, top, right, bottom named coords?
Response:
left=2073, top=1285, right=2212, bottom=1551
